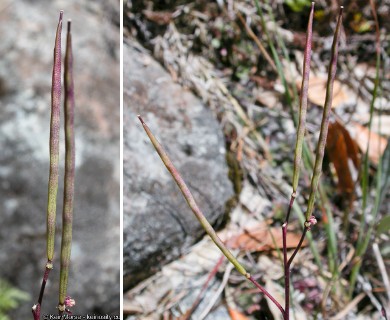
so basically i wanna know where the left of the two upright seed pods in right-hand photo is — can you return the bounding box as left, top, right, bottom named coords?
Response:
left=293, top=2, right=314, bottom=195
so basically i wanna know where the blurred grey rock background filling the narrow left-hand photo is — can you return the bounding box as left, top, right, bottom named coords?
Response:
left=0, top=0, right=120, bottom=319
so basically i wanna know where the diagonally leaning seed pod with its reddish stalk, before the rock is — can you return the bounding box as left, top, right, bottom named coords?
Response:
left=138, top=116, right=284, bottom=315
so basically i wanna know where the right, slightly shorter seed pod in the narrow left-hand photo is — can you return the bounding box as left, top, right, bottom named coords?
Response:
left=59, top=21, right=75, bottom=310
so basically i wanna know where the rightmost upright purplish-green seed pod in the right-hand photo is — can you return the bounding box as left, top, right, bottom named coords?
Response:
left=305, top=7, right=344, bottom=222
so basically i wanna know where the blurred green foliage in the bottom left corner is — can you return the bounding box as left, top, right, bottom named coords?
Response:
left=0, top=279, right=30, bottom=320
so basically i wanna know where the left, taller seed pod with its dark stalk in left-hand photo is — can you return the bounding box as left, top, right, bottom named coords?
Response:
left=32, top=11, right=63, bottom=320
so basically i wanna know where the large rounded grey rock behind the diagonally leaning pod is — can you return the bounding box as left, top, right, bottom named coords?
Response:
left=123, top=39, right=233, bottom=289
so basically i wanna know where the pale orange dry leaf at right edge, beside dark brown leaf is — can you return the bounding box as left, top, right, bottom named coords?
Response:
left=353, top=122, right=387, bottom=165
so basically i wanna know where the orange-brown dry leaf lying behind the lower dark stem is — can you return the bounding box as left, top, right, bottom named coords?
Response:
left=227, top=222, right=307, bottom=251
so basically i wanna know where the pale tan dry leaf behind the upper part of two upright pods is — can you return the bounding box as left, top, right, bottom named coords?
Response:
left=297, top=76, right=349, bottom=108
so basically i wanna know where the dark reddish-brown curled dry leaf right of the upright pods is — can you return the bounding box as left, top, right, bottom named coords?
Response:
left=326, top=122, right=360, bottom=194
